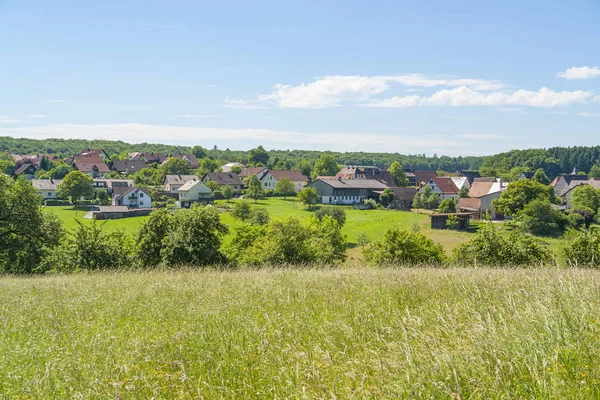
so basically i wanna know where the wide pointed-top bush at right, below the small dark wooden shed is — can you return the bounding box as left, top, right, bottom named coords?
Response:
left=454, top=222, right=551, bottom=267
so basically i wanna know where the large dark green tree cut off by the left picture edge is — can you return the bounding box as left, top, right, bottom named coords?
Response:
left=0, top=174, right=63, bottom=274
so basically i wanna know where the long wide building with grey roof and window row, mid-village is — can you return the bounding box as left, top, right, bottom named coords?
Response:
left=306, top=177, right=387, bottom=204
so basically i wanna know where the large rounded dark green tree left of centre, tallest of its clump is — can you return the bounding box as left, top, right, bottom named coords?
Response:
left=160, top=204, right=229, bottom=266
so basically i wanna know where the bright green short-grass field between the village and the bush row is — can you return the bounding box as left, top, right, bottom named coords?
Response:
left=45, top=198, right=470, bottom=259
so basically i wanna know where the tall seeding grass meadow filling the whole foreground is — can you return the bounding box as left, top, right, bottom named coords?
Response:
left=0, top=269, right=600, bottom=399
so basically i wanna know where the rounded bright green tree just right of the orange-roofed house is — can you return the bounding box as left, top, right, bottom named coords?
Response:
left=492, top=179, right=557, bottom=216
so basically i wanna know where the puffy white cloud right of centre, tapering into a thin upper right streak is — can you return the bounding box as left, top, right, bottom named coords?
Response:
left=225, top=74, right=504, bottom=108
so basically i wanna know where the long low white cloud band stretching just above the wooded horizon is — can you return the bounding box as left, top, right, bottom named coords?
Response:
left=0, top=123, right=498, bottom=155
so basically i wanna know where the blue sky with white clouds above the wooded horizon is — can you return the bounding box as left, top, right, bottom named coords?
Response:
left=0, top=0, right=600, bottom=156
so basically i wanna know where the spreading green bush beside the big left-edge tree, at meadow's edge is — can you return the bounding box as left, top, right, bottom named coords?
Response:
left=42, top=221, right=133, bottom=272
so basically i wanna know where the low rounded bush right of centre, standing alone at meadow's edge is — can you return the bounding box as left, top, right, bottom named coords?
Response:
left=363, top=228, right=445, bottom=265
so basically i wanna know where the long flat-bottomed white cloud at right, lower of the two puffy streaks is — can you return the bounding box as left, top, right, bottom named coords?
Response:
left=365, top=86, right=594, bottom=108
